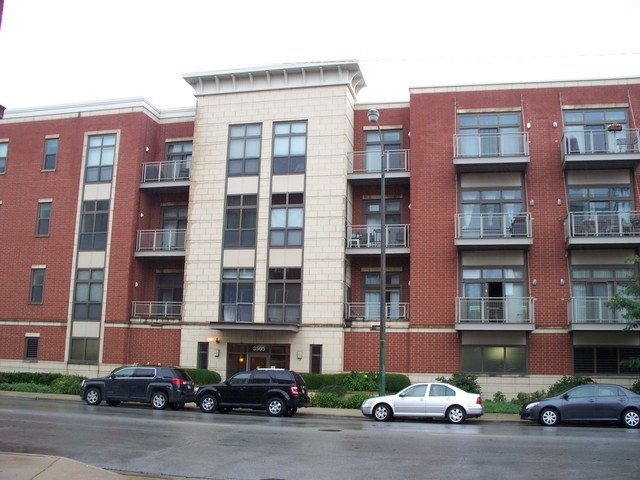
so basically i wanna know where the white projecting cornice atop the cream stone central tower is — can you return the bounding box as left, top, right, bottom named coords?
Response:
left=182, top=60, right=366, bottom=97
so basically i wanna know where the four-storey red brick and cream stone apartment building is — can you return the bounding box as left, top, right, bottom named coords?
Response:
left=0, top=62, right=640, bottom=394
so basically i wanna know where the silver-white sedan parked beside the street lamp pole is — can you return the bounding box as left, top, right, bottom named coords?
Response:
left=360, top=383, right=484, bottom=423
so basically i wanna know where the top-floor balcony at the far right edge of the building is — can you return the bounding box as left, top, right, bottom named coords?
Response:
left=562, top=128, right=640, bottom=170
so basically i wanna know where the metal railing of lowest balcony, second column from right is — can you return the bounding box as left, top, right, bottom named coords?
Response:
left=456, top=297, right=535, bottom=324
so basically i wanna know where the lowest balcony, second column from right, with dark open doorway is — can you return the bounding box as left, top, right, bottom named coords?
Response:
left=456, top=297, right=535, bottom=331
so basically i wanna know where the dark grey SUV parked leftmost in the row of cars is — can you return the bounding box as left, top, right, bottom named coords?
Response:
left=80, top=365, right=194, bottom=410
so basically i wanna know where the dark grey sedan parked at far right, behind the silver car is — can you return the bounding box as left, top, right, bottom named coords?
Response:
left=520, top=383, right=640, bottom=428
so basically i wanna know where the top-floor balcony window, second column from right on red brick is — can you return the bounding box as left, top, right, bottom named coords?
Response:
left=457, top=112, right=524, bottom=157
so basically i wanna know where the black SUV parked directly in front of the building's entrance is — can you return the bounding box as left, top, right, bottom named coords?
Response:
left=195, top=367, right=309, bottom=417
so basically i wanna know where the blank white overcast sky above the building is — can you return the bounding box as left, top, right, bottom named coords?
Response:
left=0, top=0, right=640, bottom=109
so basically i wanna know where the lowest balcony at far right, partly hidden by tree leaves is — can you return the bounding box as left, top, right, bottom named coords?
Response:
left=567, top=297, right=627, bottom=332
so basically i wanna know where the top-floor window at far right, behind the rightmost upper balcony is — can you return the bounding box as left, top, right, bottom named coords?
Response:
left=563, top=109, right=628, bottom=154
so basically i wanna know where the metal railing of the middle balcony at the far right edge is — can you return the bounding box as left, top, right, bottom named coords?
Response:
left=564, top=211, right=640, bottom=238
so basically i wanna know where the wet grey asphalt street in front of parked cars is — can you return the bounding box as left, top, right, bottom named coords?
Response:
left=0, top=394, right=640, bottom=480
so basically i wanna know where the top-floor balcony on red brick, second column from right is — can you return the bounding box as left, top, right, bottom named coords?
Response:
left=453, top=132, right=529, bottom=172
